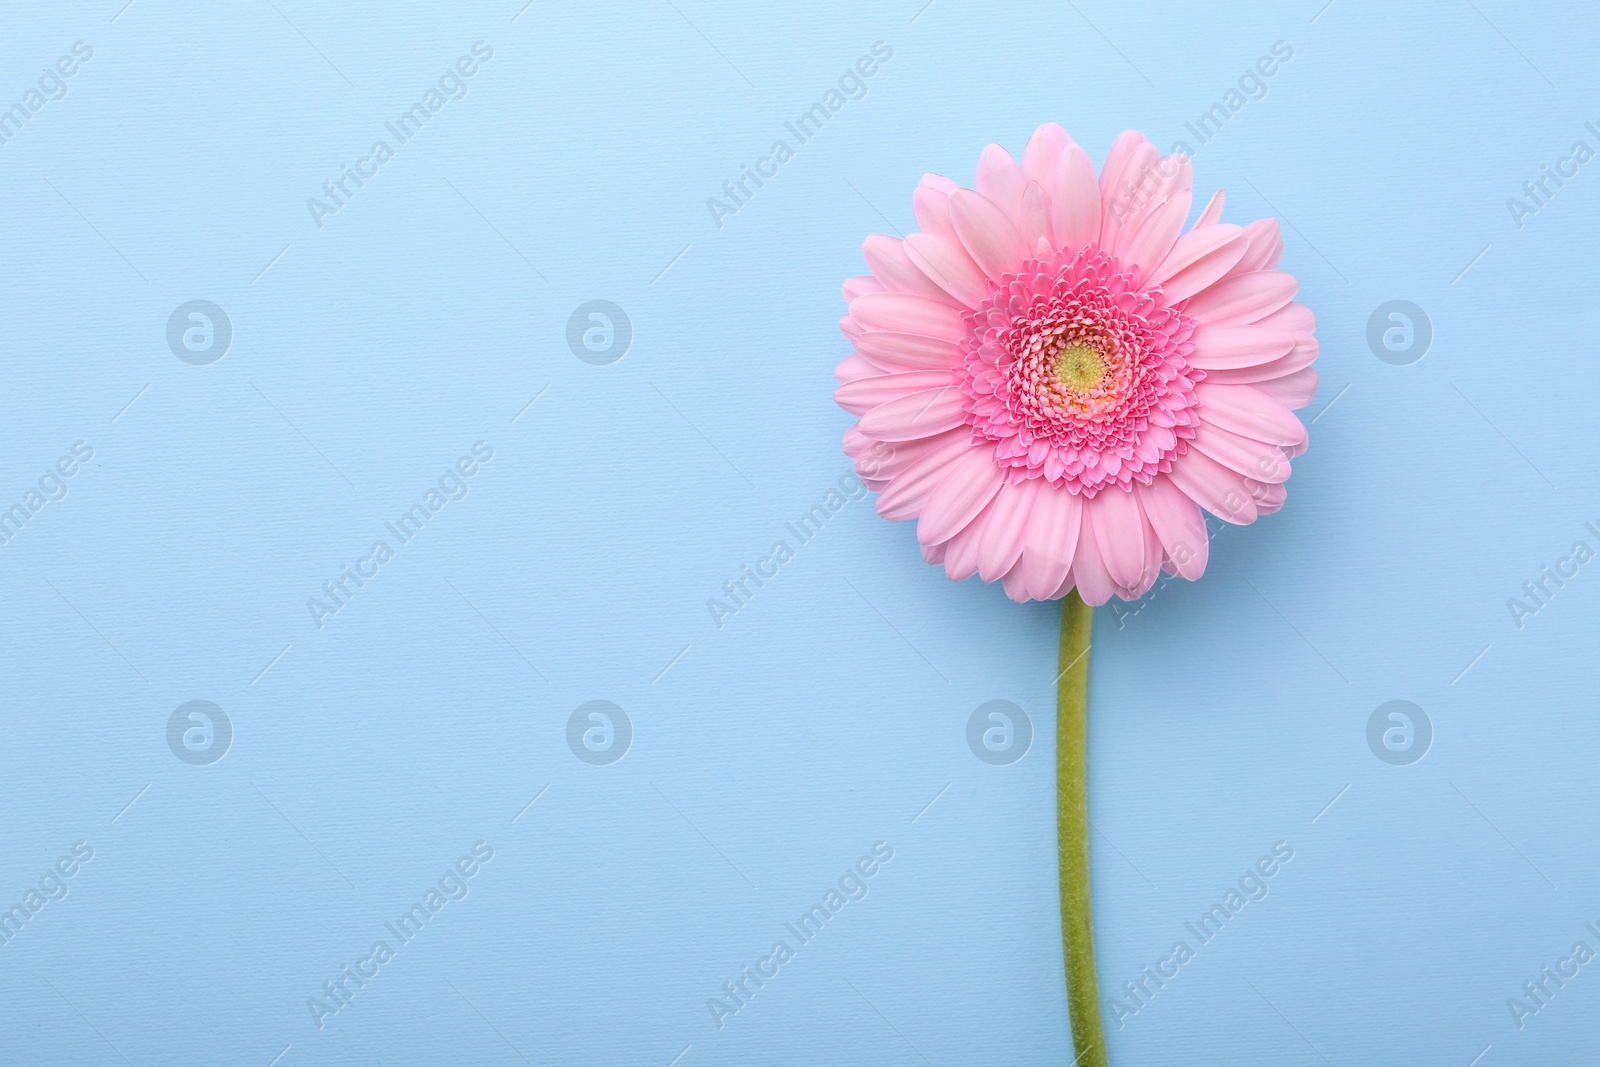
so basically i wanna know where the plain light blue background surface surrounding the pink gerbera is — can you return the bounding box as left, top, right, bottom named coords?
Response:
left=0, top=0, right=1600, bottom=1067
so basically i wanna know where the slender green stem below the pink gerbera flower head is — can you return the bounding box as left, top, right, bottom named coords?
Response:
left=1056, top=589, right=1106, bottom=1067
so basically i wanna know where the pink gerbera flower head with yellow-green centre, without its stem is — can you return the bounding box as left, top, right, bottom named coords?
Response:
left=834, top=125, right=1317, bottom=605
